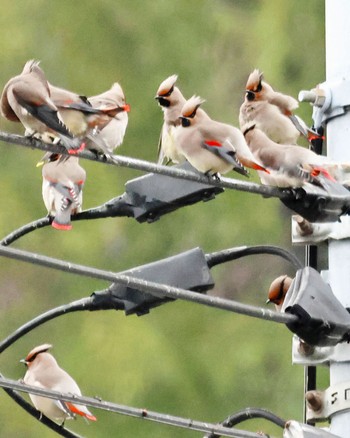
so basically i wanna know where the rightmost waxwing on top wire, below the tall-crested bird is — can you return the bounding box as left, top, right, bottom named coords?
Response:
left=243, top=124, right=334, bottom=187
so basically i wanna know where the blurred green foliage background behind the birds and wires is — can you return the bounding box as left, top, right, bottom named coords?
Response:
left=0, top=0, right=326, bottom=438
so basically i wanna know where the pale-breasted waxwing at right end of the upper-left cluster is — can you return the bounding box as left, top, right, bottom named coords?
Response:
left=87, top=82, right=130, bottom=155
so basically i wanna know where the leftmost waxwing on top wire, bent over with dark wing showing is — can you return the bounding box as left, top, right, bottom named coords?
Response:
left=0, top=60, right=81, bottom=151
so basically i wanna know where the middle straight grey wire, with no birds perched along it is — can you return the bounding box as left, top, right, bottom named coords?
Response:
left=0, top=246, right=298, bottom=324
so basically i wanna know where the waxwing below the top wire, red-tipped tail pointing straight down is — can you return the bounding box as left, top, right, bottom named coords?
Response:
left=42, top=154, right=86, bottom=230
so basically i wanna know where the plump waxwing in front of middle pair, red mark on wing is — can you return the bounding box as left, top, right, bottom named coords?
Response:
left=175, top=96, right=264, bottom=176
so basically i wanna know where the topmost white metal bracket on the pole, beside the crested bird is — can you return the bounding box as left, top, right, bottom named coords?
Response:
left=298, top=80, right=350, bottom=129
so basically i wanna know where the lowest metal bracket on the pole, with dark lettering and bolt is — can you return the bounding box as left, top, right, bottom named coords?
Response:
left=305, top=381, right=350, bottom=421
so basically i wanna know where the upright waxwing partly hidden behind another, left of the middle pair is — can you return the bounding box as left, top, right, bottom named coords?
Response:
left=155, top=75, right=186, bottom=164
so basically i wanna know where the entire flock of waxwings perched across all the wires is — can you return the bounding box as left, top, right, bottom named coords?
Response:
left=0, top=60, right=349, bottom=423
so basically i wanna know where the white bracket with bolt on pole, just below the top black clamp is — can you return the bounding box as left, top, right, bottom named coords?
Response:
left=292, top=215, right=350, bottom=245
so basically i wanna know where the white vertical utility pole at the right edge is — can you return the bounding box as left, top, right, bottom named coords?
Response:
left=326, top=0, right=350, bottom=438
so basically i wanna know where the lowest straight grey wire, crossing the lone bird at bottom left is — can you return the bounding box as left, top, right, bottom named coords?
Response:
left=0, top=377, right=267, bottom=438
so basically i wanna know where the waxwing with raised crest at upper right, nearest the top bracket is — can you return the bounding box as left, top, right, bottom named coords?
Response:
left=239, top=69, right=319, bottom=144
